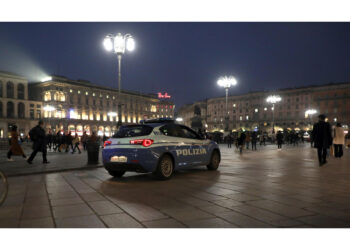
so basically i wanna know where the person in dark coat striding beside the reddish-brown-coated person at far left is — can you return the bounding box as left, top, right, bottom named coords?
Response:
left=27, top=121, right=50, bottom=164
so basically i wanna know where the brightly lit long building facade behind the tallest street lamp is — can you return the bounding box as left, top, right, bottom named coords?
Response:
left=29, top=76, right=174, bottom=136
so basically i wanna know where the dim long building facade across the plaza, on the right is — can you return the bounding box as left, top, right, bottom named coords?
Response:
left=178, top=83, right=350, bottom=132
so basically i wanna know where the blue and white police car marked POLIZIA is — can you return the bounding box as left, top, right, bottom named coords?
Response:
left=102, top=119, right=221, bottom=180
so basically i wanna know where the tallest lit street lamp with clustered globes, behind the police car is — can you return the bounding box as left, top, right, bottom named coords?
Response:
left=103, top=33, right=135, bottom=127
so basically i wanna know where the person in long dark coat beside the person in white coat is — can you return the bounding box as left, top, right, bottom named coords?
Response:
left=312, top=115, right=332, bottom=167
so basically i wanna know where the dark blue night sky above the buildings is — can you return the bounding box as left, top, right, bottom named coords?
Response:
left=0, top=23, right=350, bottom=107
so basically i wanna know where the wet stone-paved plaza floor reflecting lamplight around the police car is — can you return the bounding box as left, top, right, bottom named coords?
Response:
left=0, top=144, right=350, bottom=228
